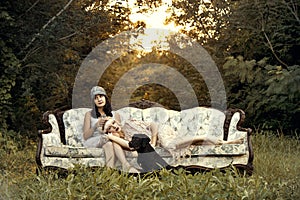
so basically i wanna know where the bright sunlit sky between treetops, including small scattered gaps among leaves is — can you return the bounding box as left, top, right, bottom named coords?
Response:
left=85, top=0, right=214, bottom=54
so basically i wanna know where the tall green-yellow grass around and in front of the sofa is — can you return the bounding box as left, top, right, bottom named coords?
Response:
left=0, top=132, right=300, bottom=200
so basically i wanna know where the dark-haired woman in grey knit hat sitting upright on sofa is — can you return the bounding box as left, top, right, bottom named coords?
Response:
left=83, top=86, right=138, bottom=173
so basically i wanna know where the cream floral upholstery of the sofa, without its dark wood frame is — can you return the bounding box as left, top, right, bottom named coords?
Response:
left=40, top=107, right=249, bottom=172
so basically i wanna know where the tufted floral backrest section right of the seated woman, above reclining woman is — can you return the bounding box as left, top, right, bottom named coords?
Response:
left=116, top=107, right=225, bottom=139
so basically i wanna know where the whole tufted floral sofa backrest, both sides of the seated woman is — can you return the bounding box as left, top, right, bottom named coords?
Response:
left=63, top=107, right=229, bottom=146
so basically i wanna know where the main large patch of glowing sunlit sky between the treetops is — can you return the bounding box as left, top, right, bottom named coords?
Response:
left=108, top=0, right=188, bottom=52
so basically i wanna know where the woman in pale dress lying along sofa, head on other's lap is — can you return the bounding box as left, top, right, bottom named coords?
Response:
left=103, top=113, right=243, bottom=157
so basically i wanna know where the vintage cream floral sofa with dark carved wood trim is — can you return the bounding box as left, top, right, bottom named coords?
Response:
left=36, top=102, right=254, bottom=175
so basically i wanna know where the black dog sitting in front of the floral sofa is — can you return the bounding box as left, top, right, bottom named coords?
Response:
left=129, top=134, right=169, bottom=172
